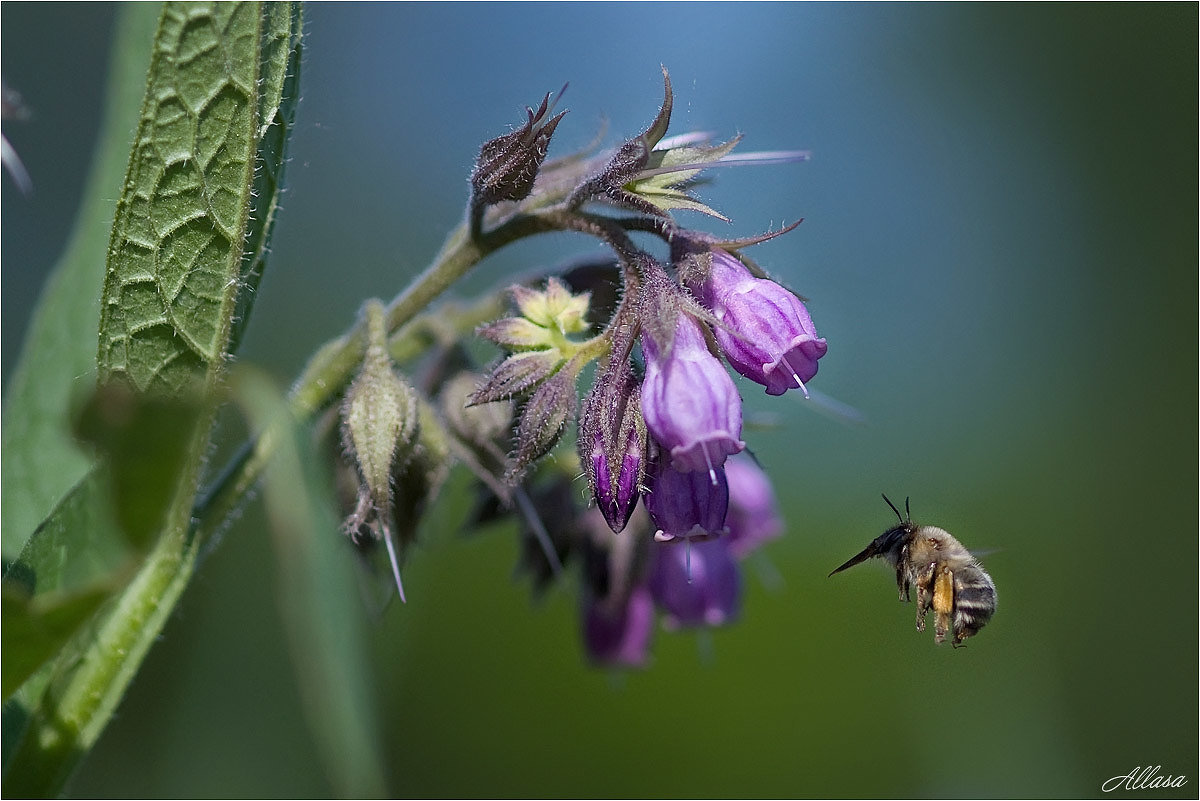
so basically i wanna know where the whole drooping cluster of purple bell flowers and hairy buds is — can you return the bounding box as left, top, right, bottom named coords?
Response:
left=336, top=71, right=827, bottom=666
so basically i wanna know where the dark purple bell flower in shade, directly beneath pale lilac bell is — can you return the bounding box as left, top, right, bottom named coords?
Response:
left=646, top=458, right=730, bottom=542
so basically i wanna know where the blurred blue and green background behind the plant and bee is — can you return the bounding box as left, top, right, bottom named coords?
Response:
left=0, top=4, right=1200, bottom=797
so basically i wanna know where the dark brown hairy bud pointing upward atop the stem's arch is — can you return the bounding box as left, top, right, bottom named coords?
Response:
left=470, top=86, right=566, bottom=205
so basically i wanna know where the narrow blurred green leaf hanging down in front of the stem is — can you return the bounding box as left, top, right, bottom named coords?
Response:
left=230, top=367, right=385, bottom=797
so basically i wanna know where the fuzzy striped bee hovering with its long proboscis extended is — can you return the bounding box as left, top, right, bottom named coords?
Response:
left=829, top=495, right=996, bottom=646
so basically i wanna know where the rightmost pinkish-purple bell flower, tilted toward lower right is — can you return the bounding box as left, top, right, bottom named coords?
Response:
left=689, top=248, right=828, bottom=396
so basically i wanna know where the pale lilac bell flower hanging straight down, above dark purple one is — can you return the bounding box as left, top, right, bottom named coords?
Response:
left=641, top=313, right=745, bottom=474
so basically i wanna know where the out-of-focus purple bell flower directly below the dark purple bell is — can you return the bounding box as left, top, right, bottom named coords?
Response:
left=650, top=537, right=742, bottom=628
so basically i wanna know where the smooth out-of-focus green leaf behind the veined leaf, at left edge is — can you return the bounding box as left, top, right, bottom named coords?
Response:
left=0, top=4, right=158, bottom=559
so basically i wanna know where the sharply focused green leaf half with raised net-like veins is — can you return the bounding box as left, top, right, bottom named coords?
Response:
left=97, top=4, right=262, bottom=392
